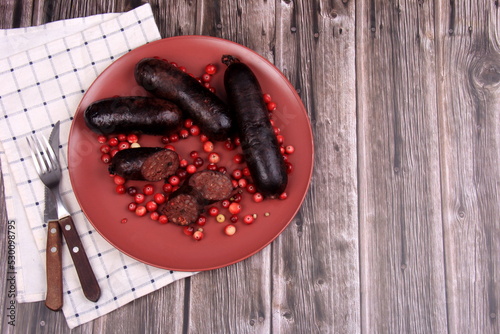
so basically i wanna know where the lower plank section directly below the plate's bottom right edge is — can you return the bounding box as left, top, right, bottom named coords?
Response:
left=187, top=254, right=271, bottom=334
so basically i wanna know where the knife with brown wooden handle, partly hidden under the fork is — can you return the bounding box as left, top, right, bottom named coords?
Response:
left=43, top=122, right=63, bottom=311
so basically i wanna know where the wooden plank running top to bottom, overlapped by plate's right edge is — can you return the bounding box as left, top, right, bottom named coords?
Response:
left=273, top=0, right=360, bottom=333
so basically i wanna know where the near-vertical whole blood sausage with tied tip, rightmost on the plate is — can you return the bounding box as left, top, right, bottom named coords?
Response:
left=222, top=55, right=288, bottom=197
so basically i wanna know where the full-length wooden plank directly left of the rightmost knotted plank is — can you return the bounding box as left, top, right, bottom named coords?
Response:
left=356, top=0, right=447, bottom=333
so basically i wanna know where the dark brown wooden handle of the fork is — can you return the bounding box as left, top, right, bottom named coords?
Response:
left=59, top=216, right=101, bottom=302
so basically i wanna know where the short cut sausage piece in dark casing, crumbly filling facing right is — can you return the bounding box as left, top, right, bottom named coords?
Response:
left=108, top=147, right=179, bottom=182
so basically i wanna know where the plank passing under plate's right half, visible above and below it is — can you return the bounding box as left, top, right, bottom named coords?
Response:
left=187, top=0, right=274, bottom=333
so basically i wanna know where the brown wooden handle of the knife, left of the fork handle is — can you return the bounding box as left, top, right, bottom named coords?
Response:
left=45, top=220, right=63, bottom=311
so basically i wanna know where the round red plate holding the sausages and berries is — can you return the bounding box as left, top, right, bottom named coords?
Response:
left=68, top=36, right=313, bottom=271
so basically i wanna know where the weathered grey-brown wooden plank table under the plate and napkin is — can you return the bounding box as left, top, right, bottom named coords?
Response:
left=0, top=0, right=500, bottom=333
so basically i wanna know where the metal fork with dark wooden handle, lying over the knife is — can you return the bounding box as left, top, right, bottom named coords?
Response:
left=27, top=135, right=101, bottom=302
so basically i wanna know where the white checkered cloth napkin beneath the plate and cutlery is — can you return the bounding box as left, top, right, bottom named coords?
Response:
left=0, top=4, right=193, bottom=328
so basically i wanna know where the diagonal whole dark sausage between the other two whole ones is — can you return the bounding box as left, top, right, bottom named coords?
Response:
left=135, top=58, right=232, bottom=141
